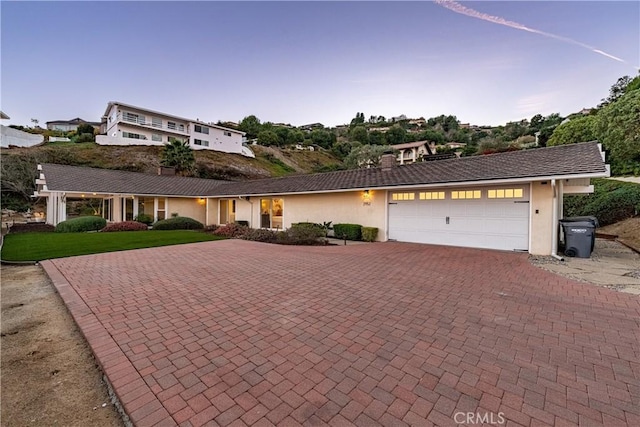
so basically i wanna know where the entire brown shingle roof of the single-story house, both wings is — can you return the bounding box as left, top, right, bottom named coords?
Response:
left=37, top=142, right=607, bottom=197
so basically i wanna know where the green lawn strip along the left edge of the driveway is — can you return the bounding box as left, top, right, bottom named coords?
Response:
left=2, top=230, right=221, bottom=261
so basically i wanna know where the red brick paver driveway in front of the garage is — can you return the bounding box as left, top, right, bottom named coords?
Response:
left=43, top=240, right=640, bottom=426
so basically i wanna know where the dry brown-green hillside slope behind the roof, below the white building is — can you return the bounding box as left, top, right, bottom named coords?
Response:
left=0, top=142, right=341, bottom=210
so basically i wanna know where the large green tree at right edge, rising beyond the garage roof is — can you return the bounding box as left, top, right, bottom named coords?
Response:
left=596, top=89, right=640, bottom=175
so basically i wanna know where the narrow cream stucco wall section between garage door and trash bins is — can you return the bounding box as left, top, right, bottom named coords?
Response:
left=529, top=181, right=555, bottom=255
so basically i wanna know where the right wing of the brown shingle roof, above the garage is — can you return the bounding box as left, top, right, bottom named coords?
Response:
left=207, top=142, right=606, bottom=196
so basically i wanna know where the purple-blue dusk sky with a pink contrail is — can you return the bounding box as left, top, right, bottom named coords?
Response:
left=0, top=1, right=640, bottom=127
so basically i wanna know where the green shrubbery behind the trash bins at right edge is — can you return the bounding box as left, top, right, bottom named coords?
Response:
left=564, top=179, right=640, bottom=226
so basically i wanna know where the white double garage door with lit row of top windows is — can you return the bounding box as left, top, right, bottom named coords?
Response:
left=389, top=186, right=529, bottom=251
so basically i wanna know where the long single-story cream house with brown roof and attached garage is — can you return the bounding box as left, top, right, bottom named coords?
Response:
left=36, top=142, right=609, bottom=255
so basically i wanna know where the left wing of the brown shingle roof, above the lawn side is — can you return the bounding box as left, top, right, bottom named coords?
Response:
left=42, top=163, right=226, bottom=197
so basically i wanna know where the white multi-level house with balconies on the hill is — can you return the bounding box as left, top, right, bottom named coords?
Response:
left=96, top=102, right=254, bottom=157
